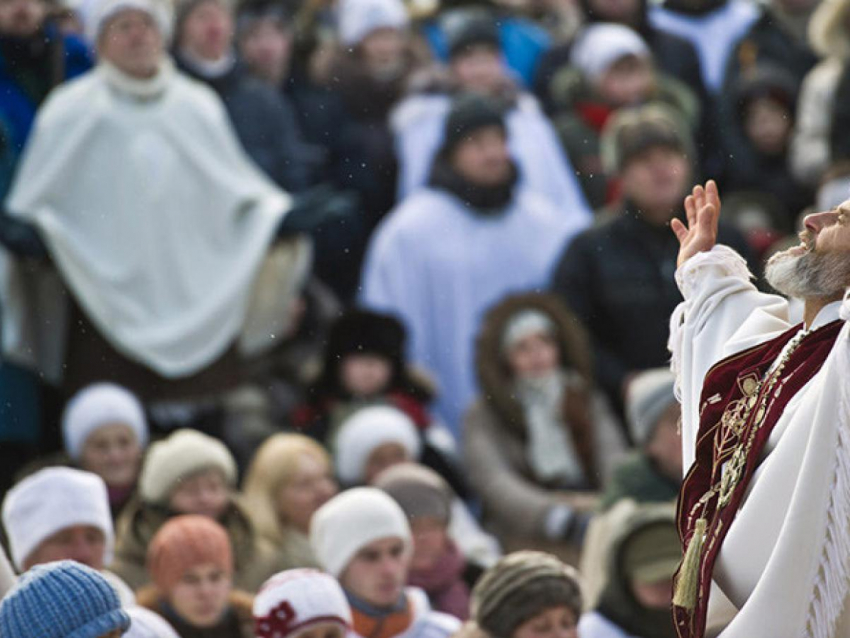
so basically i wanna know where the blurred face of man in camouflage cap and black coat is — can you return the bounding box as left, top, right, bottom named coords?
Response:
left=620, top=146, right=690, bottom=225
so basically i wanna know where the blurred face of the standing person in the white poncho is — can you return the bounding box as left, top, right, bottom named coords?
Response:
left=97, top=8, right=163, bottom=79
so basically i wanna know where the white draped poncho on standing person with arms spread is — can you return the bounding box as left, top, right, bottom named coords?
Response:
left=0, top=62, right=290, bottom=379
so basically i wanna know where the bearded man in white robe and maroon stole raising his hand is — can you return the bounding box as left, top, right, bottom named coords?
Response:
left=670, top=182, right=850, bottom=638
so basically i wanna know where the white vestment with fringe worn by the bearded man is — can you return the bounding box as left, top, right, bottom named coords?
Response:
left=670, top=246, right=850, bottom=638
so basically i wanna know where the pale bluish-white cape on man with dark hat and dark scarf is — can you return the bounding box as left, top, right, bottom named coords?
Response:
left=361, top=189, right=587, bottom=437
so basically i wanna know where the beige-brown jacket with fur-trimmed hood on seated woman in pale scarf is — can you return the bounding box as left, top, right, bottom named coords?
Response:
left=464, top=294, right=624, bottom=546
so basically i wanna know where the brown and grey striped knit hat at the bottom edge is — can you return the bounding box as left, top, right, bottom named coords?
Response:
left=471, top=551, right=582, bottom=638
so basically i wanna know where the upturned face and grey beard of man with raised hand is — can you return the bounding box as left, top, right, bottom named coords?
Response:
left=765, top=200, right=850, bottom=299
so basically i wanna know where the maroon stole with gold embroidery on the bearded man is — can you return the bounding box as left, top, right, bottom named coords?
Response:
left=673, top=321, right=843, bottom=638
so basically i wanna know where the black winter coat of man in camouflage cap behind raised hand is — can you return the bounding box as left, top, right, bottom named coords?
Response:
left=552, top=208, right=749, bottom=416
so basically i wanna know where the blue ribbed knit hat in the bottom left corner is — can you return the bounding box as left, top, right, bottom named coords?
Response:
left=0, top=560, right=130, bottom=638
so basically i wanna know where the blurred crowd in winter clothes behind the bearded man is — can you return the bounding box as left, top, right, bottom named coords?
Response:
left=0, top=0, right=850, bottom=638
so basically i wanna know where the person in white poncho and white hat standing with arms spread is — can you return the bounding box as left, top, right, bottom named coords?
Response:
left=0, top=0, right=322, bottom=398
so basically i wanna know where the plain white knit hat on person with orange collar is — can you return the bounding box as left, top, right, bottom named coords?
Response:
left=310, top=487, right=412, bottom=578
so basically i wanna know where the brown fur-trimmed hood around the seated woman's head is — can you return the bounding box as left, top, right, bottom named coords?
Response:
left=475, top=293, right=593, bottom=438
